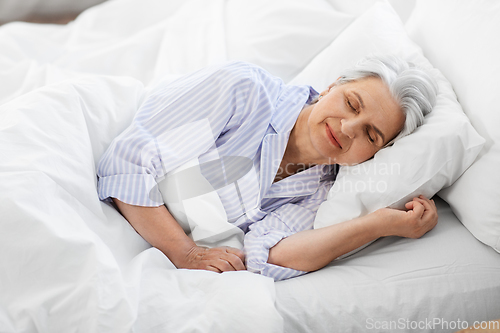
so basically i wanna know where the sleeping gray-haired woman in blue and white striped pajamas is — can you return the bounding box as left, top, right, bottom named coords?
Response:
left=98, top=56, right=437, bottom=280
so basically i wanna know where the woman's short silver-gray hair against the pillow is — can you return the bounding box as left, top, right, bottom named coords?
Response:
left=336, top=55, right=438, bottom=147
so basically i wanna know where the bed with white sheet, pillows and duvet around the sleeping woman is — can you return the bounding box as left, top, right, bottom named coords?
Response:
left=0, top=0, right=500, bottom=332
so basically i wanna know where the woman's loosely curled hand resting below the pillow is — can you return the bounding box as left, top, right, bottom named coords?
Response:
left=376, top=195, right=438, bottom=238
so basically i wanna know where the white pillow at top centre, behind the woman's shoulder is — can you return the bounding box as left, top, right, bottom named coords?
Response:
left=225, top=0, right=354, bottom=82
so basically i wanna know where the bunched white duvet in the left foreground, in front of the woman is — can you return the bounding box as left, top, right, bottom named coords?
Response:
left=0, top=76, right=282, bottom=332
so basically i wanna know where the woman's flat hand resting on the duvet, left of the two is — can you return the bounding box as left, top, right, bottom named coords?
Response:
left=182, top=246, right=246, bottom=273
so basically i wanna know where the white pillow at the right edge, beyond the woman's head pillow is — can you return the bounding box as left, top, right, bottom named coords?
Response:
left=406, top=0, right=500, bottom=252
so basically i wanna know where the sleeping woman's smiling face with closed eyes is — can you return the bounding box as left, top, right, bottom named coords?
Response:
left=308, top=77, right=405, bottom=165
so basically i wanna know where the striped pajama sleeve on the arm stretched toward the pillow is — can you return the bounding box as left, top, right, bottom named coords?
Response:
left=244, top=182, right=332, bottom=281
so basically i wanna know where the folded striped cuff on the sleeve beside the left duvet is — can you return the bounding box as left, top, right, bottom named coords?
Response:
left=97, top=174, right=163, bottom=207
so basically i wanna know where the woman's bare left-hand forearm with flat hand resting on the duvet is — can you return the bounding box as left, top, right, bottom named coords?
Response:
left=113, top=198, right=245, bottom=272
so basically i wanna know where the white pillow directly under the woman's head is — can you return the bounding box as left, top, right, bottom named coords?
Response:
left=292, top=2, right=484, bottom=236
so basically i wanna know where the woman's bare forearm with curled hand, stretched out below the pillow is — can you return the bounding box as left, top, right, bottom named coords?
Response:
left=268, top=196, right=437, bottom=272
